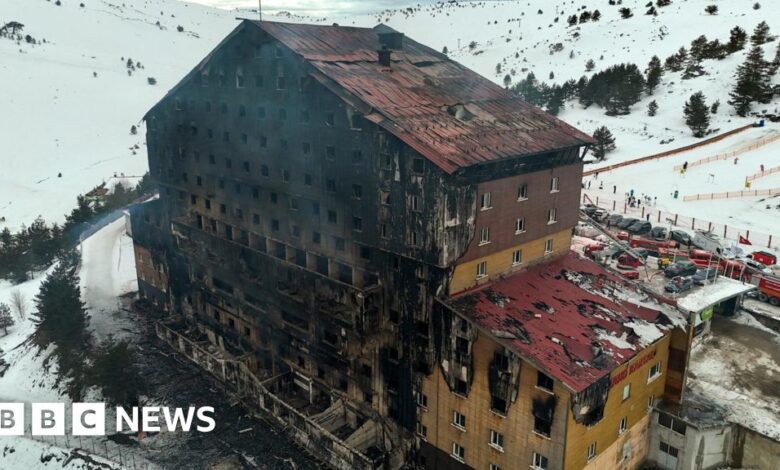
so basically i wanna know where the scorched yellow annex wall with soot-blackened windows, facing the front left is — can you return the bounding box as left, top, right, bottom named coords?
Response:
left=418, top=333, right=569, bottom=470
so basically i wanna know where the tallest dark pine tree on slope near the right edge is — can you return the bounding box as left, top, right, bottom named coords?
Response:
left=729, top=46, right=772, bottom=117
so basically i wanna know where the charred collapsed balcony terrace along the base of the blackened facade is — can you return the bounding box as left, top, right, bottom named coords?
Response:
left=155, top=320, right=400, bottom=470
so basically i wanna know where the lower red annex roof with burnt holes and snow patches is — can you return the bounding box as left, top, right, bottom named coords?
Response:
left=448, top=252, right=672, bottom=393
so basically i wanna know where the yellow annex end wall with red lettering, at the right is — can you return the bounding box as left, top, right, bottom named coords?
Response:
left=565, top=334, right=671, bottom=470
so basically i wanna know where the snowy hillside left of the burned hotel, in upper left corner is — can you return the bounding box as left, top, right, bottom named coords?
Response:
left=0, top=0, right=236, bottom=229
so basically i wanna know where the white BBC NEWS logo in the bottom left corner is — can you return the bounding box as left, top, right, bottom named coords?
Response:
left=0, top=403, right=216, bottom=436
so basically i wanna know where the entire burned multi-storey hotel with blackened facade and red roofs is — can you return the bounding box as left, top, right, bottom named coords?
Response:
left=132, top=20, right=687, bottom=470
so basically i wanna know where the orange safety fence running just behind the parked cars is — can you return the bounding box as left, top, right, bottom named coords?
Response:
left=582, top=194, right=780, bottom=248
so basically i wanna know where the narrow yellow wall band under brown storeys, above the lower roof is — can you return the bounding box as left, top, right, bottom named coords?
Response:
left=449, top=228, right=571, bottom=295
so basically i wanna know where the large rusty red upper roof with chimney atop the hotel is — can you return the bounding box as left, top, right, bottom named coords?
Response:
left=253, top=21, right=591, bottom=173
